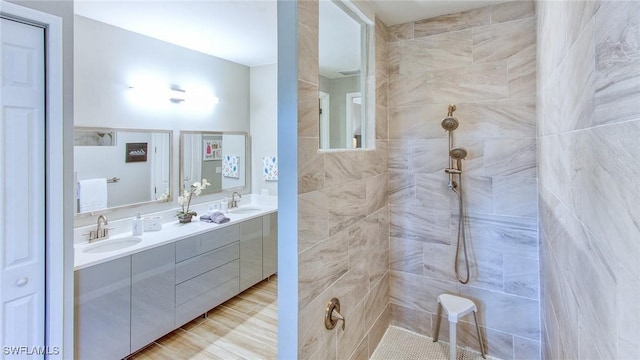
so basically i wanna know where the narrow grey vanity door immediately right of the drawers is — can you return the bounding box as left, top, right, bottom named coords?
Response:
left=240, top=217, right=263, bottom=291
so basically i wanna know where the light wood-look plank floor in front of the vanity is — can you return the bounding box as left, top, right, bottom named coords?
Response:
left=129, top=275, right=278, bottom=360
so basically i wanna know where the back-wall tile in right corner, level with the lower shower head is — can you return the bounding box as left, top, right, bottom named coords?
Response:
left=484, top=138, right=537, bottom=177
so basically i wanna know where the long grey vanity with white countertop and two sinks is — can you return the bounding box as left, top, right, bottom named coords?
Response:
left=75, top=206, right=277, bottom=359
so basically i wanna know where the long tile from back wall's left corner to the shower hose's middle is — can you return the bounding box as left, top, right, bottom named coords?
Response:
left=391, top=206, right=451, bottom=244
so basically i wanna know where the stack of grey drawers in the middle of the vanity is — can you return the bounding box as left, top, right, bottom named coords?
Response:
left=175, top=223, right=243, bottom=327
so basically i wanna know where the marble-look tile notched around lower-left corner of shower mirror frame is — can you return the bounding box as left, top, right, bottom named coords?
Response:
left=298, top=137, right=324, bottom=194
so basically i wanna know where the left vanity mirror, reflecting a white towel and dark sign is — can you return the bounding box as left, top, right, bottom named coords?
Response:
left=73, top=127, right=172, bottom=214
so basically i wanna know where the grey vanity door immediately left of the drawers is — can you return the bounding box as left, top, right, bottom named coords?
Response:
left=131, top=244, right=176, bottom=353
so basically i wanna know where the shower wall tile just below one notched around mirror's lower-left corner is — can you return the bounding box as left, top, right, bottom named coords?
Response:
left=298, top=191, right=329, bottom=251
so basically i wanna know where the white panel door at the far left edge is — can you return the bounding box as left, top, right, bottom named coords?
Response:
left=0, top=19, right=45, bottom=359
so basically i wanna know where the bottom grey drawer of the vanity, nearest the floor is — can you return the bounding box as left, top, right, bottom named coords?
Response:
left=176, top=277, right=240, bottom=327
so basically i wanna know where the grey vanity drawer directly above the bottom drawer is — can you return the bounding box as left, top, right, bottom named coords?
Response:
left=176, top=260, right=240, bottom=306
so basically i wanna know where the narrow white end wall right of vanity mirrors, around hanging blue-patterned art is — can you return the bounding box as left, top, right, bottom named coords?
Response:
left=251, top=64, right=278, bottom=195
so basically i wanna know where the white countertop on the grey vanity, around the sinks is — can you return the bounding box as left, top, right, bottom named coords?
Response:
left=74, top=197, right=278, bottom=270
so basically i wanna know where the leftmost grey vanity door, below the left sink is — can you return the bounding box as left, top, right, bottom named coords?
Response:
left=74, top=256, right=131, bottom=360
